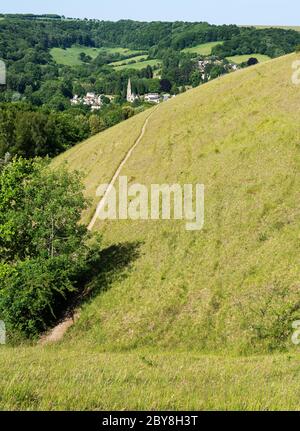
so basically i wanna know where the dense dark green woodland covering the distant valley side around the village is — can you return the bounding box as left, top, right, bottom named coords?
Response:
left=0, top=15, right=300, bottom=162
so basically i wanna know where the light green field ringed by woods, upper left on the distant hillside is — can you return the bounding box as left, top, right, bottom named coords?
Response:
left=51, top=46, right=144, bottom=66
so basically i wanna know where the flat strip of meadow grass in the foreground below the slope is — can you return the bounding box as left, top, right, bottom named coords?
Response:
left=0, top=346, right=300, bottom=411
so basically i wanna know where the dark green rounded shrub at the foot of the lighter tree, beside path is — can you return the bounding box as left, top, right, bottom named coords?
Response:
left=0, top=256, right=76, bottom=337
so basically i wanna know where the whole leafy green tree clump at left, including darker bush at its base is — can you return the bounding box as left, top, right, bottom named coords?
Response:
left=0, top=158, right=91, bottom=336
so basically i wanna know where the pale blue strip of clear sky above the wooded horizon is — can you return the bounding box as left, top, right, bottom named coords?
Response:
left=0, top=0, right=300, bottom=25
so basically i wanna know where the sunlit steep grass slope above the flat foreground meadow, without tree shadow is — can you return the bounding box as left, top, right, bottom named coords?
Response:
left=55, top=55, right=300, bottom=352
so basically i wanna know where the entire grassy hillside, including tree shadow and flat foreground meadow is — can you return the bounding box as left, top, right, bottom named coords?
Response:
left=0, top=55, right=300, bottom=410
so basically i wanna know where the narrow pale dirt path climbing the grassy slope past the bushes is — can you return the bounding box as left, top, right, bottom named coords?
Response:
left=39, top=106, right=158, bottom=345
